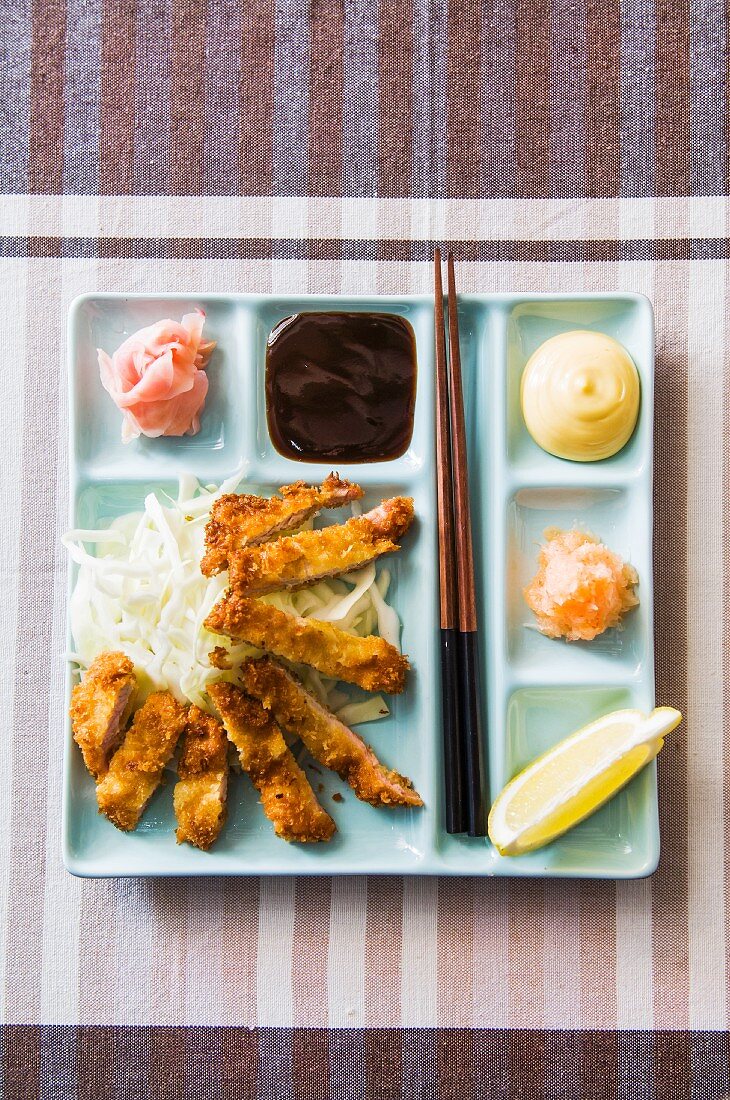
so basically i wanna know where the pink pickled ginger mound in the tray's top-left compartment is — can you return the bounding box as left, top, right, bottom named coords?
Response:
left=97, top=309, right=215, bottom=443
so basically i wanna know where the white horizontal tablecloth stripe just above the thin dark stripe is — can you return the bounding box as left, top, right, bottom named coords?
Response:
left=0, top=195, right=730, bottom=243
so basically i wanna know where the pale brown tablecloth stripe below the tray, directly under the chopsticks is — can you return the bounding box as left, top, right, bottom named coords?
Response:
left=436, top=878, right=474, bottom=1027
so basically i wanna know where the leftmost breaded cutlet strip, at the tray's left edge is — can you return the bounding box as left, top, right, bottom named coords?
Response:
left=68, top=651, right=136, bottom=780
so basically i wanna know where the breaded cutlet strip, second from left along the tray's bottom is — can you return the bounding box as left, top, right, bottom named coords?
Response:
left=97, top=691, right=188, bottom=832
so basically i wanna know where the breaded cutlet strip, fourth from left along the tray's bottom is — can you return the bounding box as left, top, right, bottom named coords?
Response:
left=208, top=681, right=335, bottom=844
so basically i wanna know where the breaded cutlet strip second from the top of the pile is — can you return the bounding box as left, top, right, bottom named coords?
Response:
left=230, top=496, right=413, bottom=596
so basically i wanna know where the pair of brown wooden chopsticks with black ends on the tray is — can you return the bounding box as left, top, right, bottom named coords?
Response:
left=434, top=249, right=487, bottom=836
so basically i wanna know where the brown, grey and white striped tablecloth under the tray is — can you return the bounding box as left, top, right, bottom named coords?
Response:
left=0, top=0, right=730, bottom=1100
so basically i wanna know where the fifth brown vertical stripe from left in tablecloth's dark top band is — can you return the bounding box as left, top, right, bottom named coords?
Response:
left=308, top=0, right=344, bottom=196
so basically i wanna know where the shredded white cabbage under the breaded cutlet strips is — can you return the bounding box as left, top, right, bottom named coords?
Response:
left=63, top=474, right=400, bottom=725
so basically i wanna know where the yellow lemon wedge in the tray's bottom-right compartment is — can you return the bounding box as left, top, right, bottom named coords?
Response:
left=489, top=706, right=682, bottom=856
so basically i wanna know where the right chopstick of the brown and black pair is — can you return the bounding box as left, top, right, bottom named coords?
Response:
left=441, top=252, right=487, bottom=836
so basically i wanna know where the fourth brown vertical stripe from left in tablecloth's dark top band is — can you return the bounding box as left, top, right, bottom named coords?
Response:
left=239, top=0, right=276, bottom=195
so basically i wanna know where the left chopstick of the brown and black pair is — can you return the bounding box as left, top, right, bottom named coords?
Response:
left=434, top=249, right=468, bottom=833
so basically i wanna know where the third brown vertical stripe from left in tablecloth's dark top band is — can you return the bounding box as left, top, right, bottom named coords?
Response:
left=170, top=0, right=206, bottom=195
